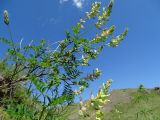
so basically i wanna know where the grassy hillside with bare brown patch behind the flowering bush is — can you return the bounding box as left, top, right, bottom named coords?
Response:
left=69, top=87, right=160, bottom=120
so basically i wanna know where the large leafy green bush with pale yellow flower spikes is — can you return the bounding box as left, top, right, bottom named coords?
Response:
left=0, top=1, right=128, bottom=120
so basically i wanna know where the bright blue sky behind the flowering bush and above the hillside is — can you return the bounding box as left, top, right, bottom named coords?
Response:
left=0, top=0, right=160, bottom=97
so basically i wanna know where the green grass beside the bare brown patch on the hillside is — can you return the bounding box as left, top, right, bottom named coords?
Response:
left=105, top=86, right=160, bottom=120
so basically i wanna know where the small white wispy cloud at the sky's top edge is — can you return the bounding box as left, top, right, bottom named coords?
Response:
left=59, top=0, right=85, bottom=8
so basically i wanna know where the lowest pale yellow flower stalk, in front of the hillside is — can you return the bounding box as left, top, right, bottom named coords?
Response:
left=79, top=80, right=112, bottom=120
